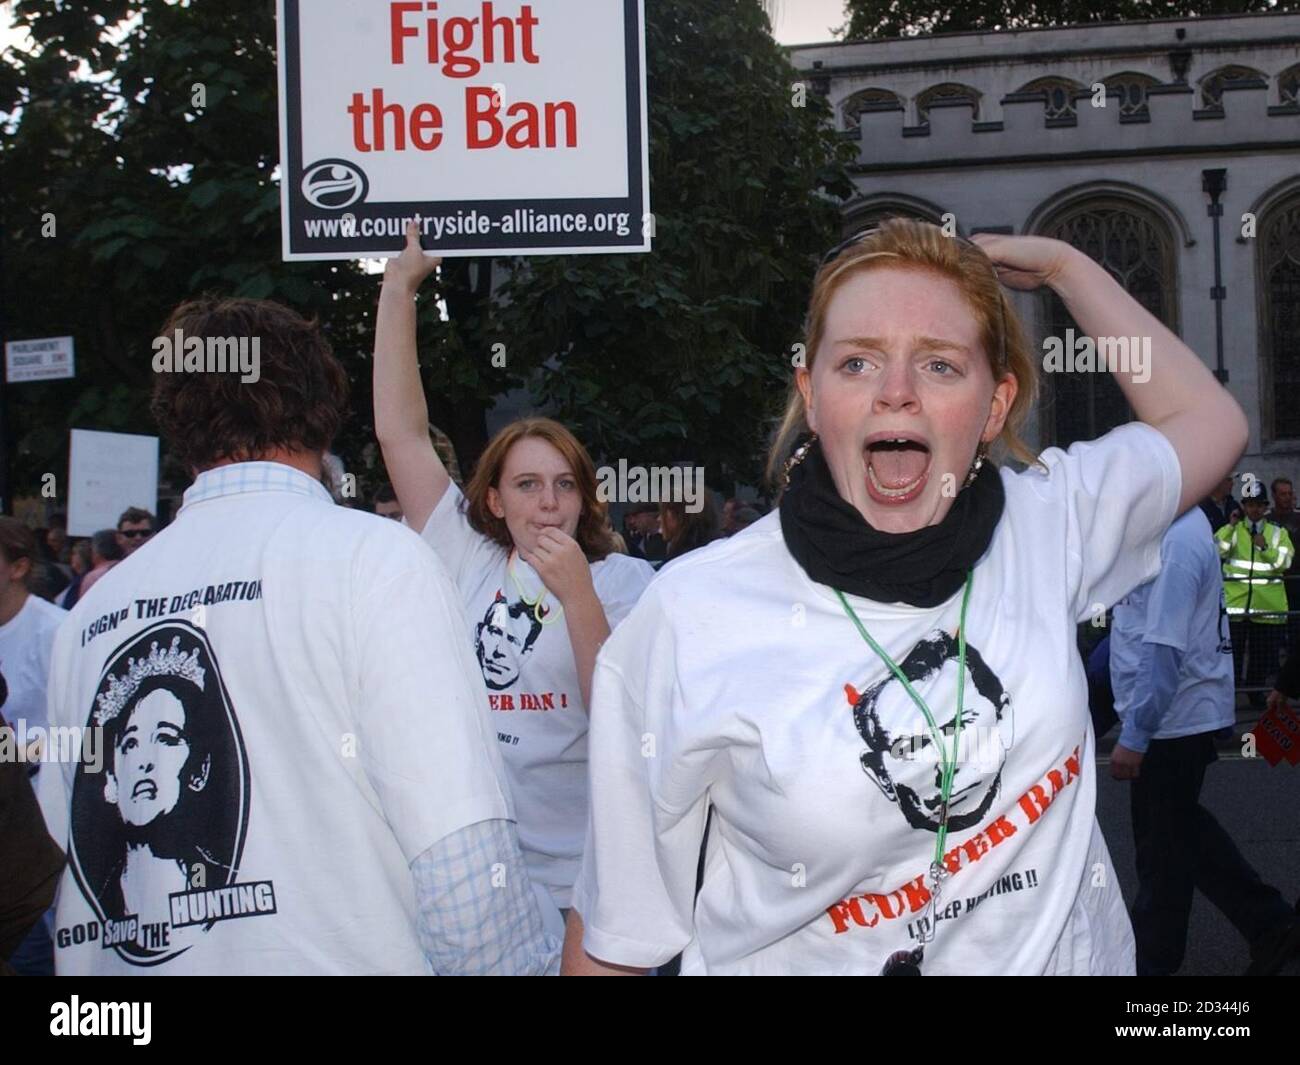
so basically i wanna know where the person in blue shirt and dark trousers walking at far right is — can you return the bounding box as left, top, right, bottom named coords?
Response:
left=1110, top=507, right=1300, bottom=977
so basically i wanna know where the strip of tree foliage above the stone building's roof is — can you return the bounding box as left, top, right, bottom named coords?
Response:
left=841, top=0, right=1294, bottom=40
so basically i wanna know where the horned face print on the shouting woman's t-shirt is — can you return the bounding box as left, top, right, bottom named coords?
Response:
left=845, top=631, right=1015, bottom=832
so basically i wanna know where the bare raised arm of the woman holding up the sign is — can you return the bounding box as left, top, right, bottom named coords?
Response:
left=374, top=222, right=451, bottom=532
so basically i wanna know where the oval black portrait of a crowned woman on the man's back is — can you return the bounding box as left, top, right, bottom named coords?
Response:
left=69, top=622, right=250, bottom=965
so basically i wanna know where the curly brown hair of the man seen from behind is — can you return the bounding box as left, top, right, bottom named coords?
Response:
left=150, top=298, right=348, bottom=471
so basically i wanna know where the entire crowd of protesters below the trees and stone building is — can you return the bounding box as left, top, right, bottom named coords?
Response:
left=0, top=220, right=1300, bottom=975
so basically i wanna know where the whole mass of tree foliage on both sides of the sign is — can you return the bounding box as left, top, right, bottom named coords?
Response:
left=0, top=0, right=848, bottom=512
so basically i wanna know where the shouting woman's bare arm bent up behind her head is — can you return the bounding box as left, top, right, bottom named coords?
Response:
left=974, top=234, right=1249, bottom=512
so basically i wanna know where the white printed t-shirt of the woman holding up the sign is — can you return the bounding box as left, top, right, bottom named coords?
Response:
left=421, top=485, right=654, bottom=908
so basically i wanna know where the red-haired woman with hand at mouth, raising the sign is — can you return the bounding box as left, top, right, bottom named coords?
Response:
left=374, top=224, right=653, bottom=909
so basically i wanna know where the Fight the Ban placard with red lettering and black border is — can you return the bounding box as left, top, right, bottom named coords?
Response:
left=280, top=0, right=653, bottom=260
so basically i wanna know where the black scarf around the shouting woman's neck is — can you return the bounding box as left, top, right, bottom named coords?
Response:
left=780, top=442, right=1006, bottom=607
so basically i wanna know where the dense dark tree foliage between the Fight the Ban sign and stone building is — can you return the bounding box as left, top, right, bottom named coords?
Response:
left=501, top=0, right=852, bottom=486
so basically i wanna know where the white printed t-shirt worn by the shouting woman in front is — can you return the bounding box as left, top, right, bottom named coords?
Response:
left=573, top=425, right=1180, bottom=974
